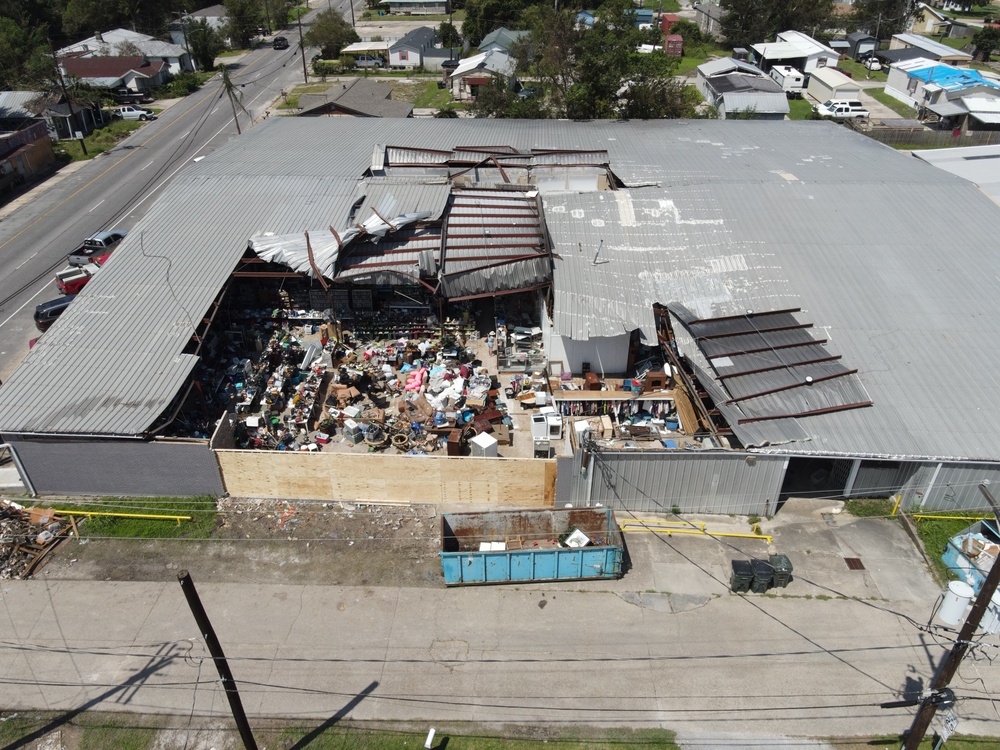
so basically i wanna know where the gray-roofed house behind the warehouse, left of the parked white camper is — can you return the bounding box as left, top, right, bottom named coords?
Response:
left=695, top=57, right=790, bottom=120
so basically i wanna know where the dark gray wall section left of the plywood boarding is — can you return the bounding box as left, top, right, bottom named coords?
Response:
left=8, top=440, right=224, bottom=497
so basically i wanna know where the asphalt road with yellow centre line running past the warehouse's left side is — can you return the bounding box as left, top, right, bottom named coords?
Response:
left=0, top=0, right=348, bottom=379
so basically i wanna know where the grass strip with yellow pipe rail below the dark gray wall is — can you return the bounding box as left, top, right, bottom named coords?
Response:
left=43, top=497, right=218, bottom=539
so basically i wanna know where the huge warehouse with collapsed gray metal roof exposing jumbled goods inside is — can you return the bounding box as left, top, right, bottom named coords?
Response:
left=0, top=118, right=1000, bottom=515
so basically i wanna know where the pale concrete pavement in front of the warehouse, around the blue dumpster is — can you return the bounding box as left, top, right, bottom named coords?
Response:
left=0, top=501, right=1000, bottom=747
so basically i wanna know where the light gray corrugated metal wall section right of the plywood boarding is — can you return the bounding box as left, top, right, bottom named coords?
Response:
left=589, top=451, right=787, bottom=515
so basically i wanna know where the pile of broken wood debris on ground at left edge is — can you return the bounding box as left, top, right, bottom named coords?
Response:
left=0, top=500, right=76, bottom=579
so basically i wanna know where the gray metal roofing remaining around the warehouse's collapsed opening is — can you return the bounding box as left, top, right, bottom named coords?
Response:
left=0, top=117, right=1000, bottom=461
